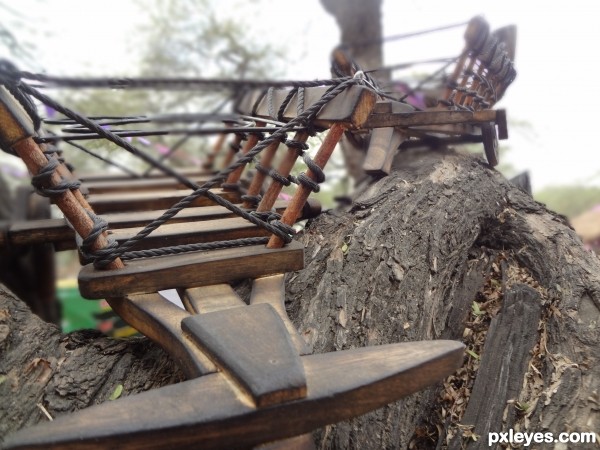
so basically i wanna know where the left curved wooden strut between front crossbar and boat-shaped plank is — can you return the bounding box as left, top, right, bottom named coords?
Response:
left=107, top=293, right=217, bottom=378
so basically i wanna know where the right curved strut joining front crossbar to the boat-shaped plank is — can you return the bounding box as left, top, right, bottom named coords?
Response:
left=250, top=273, right=312, bottom=355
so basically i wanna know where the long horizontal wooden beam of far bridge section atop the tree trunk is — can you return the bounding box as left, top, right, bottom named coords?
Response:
left=363, top=109, right=497, bottom=128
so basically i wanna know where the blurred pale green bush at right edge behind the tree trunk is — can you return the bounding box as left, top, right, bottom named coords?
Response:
left=534, top=185, right=600, bottom=218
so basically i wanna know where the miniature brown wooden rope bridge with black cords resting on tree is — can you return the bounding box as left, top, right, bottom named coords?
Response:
left=0, top=18, right=515, bottom=448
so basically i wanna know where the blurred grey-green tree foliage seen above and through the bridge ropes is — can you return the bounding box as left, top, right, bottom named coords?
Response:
left=42, top=0, right=284, bottom=172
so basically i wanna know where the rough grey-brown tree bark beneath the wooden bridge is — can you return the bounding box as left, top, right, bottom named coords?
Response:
left=0, top=151, right=600, bottom=449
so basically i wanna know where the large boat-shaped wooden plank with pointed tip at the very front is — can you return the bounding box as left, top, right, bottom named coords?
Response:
left=3, top=341, right=464, bottom=450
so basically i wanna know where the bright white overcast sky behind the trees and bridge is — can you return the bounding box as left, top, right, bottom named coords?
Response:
left=0, top=0, right=600, bottom=189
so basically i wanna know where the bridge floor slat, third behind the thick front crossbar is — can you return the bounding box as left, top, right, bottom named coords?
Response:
left=88, top=189, right=240, bottom=214
